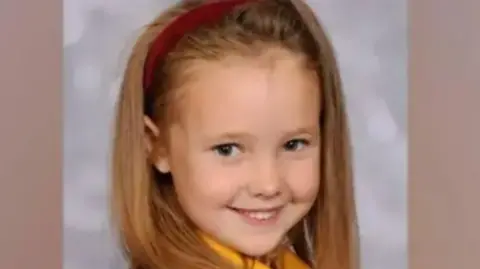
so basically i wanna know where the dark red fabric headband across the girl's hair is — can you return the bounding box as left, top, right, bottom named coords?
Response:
left=143, top=0, right=255, bottom=90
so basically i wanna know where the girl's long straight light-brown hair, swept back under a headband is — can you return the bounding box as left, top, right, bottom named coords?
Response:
left=112, top=0, right=358, bottom=269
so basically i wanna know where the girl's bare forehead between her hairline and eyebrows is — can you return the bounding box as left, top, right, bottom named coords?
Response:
left=174, top=55, right=320, bottom=133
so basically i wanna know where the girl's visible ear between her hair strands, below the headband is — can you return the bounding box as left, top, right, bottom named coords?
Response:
left=144, top=116, right=170, bottom=174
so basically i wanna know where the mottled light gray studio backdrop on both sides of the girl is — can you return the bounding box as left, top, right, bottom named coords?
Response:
left=64, top=0, right=407, bottom=269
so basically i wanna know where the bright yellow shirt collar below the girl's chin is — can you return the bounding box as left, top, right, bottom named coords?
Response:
left=204, top=236, right=309, bottom=269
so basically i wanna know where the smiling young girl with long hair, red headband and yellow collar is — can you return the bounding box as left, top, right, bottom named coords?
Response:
left=112, top=0, right=357, bottom=269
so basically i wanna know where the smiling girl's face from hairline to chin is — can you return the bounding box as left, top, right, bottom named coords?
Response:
left=158, top=50, right=320, bottom=256
